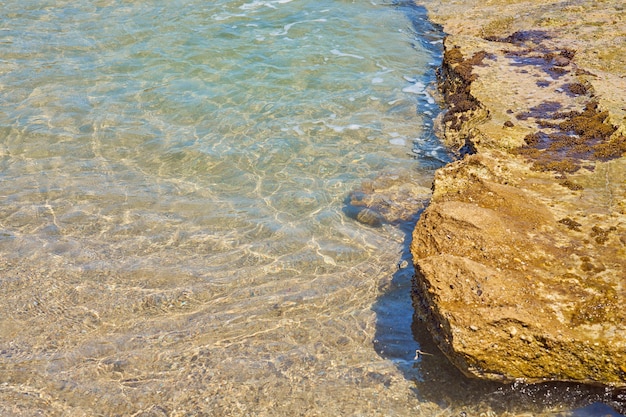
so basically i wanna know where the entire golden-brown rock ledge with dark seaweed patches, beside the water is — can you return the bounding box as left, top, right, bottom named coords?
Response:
left=411, top=0, right=626, bottom=387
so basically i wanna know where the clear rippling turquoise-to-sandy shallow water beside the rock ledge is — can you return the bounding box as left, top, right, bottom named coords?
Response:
left=0, top=0, right=620, bottom=416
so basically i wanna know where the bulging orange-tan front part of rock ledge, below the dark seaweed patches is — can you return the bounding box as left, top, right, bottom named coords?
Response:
left=411, top=154, right=626, bottom=386
